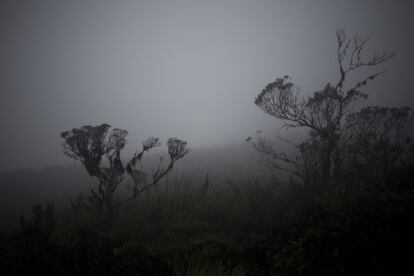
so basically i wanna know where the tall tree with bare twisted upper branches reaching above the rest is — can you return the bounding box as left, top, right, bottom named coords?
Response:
left=248, top=30, right=395, bottom=182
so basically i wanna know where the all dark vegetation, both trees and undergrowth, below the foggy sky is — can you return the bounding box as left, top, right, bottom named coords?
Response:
left=0, top=30, right=414, bottom=275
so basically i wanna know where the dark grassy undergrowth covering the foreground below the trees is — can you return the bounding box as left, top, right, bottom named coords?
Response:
left=0, top=167, right=414, bottom=275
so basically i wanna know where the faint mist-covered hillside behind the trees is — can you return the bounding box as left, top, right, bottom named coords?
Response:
left=0, top=144, right=271, bottom=232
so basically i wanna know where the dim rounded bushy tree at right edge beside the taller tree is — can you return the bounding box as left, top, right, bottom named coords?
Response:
left=346, top=106, right=414, bottom=182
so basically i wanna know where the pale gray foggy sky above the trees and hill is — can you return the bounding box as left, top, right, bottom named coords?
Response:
left=0, top=0, right=414, bottom=169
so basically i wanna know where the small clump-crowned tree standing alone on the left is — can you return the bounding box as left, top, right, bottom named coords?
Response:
left=61, top=124, right=189, bottom=225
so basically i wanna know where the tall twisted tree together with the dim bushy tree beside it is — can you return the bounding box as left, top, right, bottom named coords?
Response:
left=248, top=30, right=414, bottom=188
